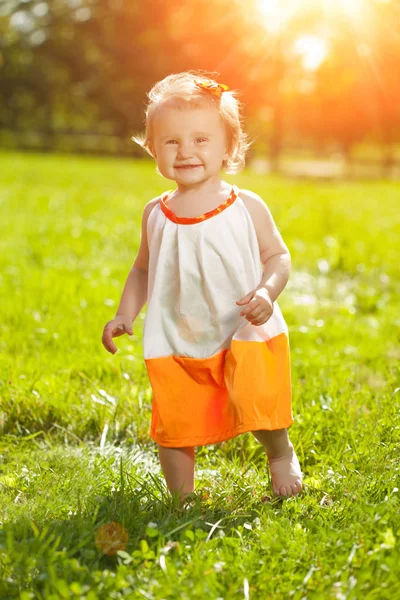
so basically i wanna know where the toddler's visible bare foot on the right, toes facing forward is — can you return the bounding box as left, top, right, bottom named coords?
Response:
left=268, top=444, right=303, bottom=497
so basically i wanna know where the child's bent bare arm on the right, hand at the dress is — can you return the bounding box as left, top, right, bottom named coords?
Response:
left=238, top=190, right=291, bottom=325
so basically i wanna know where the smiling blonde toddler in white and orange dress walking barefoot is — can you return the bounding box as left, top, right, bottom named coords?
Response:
left=102, top=71, right=302, bottom=498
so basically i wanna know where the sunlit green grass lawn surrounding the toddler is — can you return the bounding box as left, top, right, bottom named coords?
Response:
left=0, top=153, right=400, bottom=600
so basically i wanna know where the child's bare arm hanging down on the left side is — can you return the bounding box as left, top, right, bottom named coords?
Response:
left=102, top=198, right=159, bottom=354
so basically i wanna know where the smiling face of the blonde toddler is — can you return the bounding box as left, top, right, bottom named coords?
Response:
left=152, top=105, right=229, bottom=188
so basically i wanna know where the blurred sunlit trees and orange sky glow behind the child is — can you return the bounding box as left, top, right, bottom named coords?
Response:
left=0, top=0, right=400, bottom=178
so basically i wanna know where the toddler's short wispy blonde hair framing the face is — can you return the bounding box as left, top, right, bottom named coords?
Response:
left=132, top=71, right=250, bottom=174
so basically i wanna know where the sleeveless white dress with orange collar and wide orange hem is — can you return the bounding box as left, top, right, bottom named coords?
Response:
left=143, top=186, right=293, bottom=448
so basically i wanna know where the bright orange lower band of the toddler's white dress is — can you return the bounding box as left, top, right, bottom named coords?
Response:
left=145, top=333, right=293, bottom=448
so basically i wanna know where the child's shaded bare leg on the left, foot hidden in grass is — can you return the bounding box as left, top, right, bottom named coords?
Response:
left=158, top=445, right=194, bottom=500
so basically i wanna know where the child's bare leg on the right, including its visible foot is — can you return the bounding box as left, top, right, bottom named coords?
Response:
left=252, top=429, right=303, bottom=496
